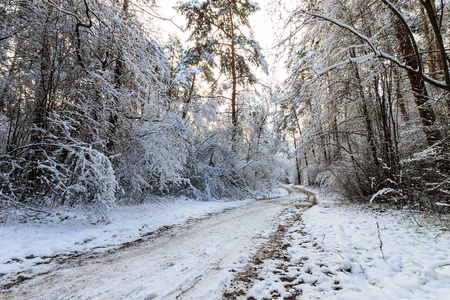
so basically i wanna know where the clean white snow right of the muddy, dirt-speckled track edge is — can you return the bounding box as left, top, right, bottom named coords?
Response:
left=293, top=206, right=450, bottom=299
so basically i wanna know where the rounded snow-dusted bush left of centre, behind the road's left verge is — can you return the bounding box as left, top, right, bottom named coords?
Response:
left=115, top=113, right=190, bottom=202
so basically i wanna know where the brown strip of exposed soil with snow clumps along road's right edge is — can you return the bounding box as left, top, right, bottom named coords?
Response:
left=222, top=187, right=341, bottom=300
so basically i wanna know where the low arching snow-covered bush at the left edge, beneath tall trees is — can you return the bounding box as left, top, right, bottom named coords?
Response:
left=0, top=140, right=117, bottom=211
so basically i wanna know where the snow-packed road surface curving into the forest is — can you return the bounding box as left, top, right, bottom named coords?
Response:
left=0, top=189, right=303, bottom=299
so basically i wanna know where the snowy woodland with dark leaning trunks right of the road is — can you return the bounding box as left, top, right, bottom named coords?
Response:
left=278, top=0, right=450, bottom=212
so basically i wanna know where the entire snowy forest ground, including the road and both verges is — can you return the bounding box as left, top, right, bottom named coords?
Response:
left=0, top=187, right=450, bottom=300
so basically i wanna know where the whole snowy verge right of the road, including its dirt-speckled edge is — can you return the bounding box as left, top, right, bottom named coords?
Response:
left=243, top=191, right=450, bottom=299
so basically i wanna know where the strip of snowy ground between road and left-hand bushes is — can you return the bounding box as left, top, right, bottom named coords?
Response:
left=0, top=188, right=287, bottom=286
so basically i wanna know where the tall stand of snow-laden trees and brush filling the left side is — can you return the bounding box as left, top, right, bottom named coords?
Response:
left=0, top=0, right=168, bottom=210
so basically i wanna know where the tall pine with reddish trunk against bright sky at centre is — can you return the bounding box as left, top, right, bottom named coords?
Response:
left=177, top=0, right=267, bottom=142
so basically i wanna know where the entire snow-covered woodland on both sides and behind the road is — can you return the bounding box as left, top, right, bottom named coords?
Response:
left=0, top=0, right=450, bottom=216
